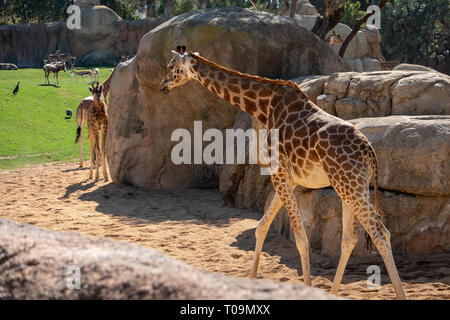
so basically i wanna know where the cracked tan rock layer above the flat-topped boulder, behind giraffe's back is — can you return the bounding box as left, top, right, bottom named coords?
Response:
left=322, top=71, right=450, bottom=119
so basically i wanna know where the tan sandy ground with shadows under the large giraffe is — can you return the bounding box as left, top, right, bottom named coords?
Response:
left=0, top=162, right=450, bottom=300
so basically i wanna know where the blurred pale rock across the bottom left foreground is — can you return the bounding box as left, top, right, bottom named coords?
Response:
left=0, top=219, right=339, bottom=298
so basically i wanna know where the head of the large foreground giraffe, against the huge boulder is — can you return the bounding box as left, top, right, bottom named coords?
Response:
left=160, top=46, right=199, bottom=93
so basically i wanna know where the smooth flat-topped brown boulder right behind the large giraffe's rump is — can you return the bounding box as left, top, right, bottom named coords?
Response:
left=350, top=116, right=450, bottom=197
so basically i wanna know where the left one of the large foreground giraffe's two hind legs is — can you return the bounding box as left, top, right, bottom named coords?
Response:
left=331, top=201, right=358, bottom=294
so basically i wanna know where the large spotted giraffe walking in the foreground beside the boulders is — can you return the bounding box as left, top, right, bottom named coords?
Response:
left=160, top=46, right=406, bottom=299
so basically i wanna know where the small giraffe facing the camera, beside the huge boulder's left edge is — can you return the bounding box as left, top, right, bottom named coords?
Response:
left=87, top=82, right=108, bottom=181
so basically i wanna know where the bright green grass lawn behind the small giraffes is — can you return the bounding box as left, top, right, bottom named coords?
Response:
left=0, top=68, right=110, bottom=169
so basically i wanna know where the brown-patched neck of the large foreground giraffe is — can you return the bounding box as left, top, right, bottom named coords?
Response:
left=190, top=59, right=275, bottom=124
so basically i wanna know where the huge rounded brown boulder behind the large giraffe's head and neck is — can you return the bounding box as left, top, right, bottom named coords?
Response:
left=107, top=8, right=348, bottom=188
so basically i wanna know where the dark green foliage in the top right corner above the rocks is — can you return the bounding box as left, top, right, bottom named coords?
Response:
left=380, top=0, right=450, bottom=73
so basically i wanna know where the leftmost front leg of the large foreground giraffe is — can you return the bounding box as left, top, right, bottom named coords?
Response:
left=250, top=191, right=282, bottom=278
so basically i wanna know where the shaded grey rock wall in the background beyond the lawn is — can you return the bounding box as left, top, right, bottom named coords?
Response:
left=0, top=6, right=167, bottom=68
